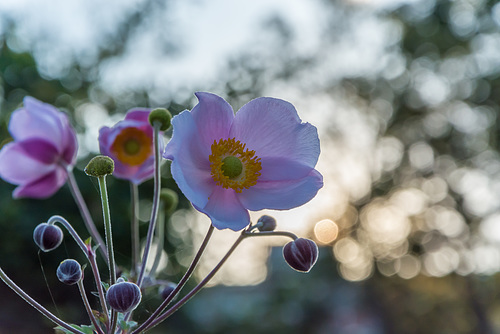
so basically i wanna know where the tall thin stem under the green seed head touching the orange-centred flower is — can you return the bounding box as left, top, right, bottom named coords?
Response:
left=137, top=122, right=161, bottom=288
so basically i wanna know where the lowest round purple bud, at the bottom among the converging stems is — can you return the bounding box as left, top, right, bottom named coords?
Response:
left=106, top=278, right=141, bottom=313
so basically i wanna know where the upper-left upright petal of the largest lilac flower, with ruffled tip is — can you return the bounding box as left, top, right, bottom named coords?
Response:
left=191, top=93, right=234, bottom=155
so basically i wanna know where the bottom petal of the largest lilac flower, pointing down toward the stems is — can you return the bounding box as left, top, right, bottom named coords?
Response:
left=198, top=186, right=250, bottom=231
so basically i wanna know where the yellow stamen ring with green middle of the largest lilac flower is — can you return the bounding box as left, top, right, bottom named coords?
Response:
left=208, top=138, right=262, bottom=193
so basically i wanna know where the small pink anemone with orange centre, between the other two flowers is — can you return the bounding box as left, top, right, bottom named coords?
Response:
left=99, top=108, right=160, bottom=184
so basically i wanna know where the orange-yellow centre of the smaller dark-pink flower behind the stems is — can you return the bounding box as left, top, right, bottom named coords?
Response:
left=111, top=128, right=152, bottom=166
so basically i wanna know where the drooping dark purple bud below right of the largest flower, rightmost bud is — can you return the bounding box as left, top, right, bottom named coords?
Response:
left=283, top=238, right=318, bottom=273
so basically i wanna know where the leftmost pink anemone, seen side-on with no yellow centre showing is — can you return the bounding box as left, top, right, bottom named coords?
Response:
left=0, top=96, right=78, bottom=198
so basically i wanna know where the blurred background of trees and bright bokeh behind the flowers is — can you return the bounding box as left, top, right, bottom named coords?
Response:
left=0, top=0, right=500, bottom=334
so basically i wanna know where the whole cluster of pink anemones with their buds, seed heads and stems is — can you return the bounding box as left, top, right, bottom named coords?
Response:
left=0, top=93, right=323, bottom=334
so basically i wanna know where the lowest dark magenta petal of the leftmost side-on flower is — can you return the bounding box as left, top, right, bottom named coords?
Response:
left=13, top=168, right=67, bottom=198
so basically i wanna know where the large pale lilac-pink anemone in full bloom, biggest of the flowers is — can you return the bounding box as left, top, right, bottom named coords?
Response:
left=163, top=93, right=323, bottom=231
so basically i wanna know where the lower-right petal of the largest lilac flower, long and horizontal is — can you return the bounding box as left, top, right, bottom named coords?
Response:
left=239, top=169, right=323, bottom=211
